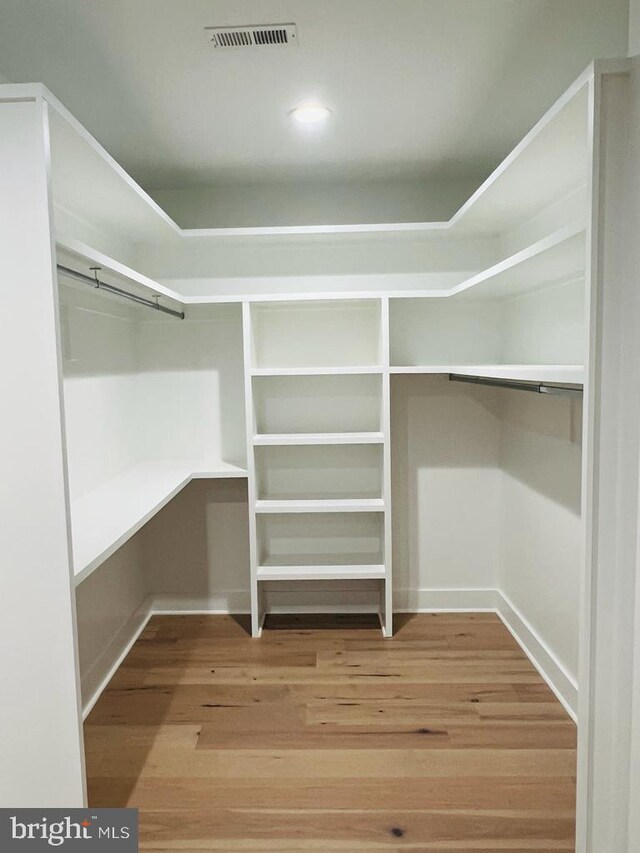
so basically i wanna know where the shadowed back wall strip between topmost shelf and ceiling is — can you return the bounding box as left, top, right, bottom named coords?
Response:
left=153, top=175, right=483, bottom=228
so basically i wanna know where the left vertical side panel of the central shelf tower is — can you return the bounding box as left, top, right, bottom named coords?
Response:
left=242, top=302, right=265, bottom=637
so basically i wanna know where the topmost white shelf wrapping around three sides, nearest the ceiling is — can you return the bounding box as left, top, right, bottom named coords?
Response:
left=0, top=66, right=592, bottom=250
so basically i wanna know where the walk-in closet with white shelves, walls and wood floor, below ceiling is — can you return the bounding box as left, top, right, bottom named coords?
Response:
left=0, top=0, right=640, bottom=853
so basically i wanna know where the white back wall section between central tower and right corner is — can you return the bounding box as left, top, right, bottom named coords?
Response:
left=391, top=376, right=502, bottom=609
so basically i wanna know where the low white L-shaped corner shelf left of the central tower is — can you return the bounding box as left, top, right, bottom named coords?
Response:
left=71, top=462, right=247, bottom=584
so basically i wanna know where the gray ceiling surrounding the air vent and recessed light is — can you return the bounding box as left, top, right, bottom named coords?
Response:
left=0, top=0, right=627, bottom=190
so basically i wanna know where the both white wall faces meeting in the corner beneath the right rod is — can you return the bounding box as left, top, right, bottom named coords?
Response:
left=391, top=375, right=582, bottom=712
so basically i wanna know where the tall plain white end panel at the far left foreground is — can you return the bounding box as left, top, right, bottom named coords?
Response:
left=0, top=96, right=85, bottom=808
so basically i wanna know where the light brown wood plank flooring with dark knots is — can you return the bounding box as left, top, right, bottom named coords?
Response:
left=85, top=613, right=576, bottom=853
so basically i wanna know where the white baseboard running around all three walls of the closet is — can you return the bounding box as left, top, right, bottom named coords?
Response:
left=83, top=588, right=578, bottom=722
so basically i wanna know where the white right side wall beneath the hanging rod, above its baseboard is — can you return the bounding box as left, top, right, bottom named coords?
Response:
left=497, top=391, right=582, bottom=682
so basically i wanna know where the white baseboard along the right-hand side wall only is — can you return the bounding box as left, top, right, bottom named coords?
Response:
left=496, top=590, right=578, bottom=723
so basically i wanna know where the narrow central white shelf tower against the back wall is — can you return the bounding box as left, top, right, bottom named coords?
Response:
left=244, top=299, right=393, bottom=636
